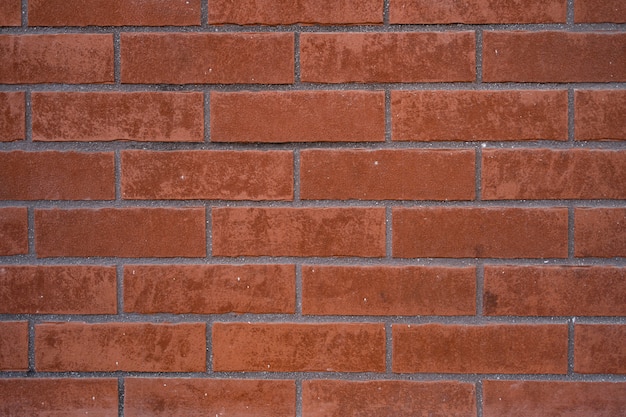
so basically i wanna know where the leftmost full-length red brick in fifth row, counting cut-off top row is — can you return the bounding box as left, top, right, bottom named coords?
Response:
left=35, top=207, right=206, bottom=258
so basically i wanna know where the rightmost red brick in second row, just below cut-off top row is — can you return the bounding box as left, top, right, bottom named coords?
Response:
left=483, top=31, right=626, bottom=83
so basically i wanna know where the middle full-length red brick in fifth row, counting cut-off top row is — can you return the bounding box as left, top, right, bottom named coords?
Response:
left=212, top=207, right=385, bottom=257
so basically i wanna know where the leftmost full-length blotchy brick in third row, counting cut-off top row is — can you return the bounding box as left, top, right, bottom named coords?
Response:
left=32, top=92, right=204, bottom=142
